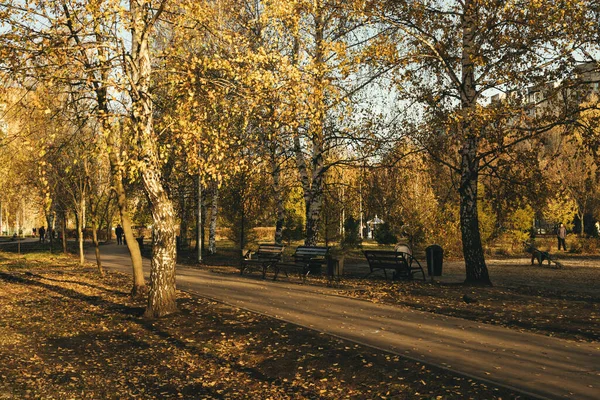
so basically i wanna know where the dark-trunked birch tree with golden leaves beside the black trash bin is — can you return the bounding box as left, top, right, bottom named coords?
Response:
left=367, top=0, right=584, bottom=285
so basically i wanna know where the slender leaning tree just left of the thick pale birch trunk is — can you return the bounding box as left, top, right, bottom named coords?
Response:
left=2, top=0, right=145, bottom=295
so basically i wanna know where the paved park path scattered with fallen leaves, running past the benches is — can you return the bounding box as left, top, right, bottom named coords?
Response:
left=90, top=245, right=600, bottom=400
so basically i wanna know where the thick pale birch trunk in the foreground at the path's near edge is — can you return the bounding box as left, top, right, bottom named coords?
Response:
left=128, top=0, right=177, bottom=318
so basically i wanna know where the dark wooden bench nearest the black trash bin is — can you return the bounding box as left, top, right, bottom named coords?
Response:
left=363, top=250, right=426, bottom=280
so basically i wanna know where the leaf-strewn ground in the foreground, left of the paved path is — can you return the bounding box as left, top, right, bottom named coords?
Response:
left=0, top=253, right=522, bottom=399
